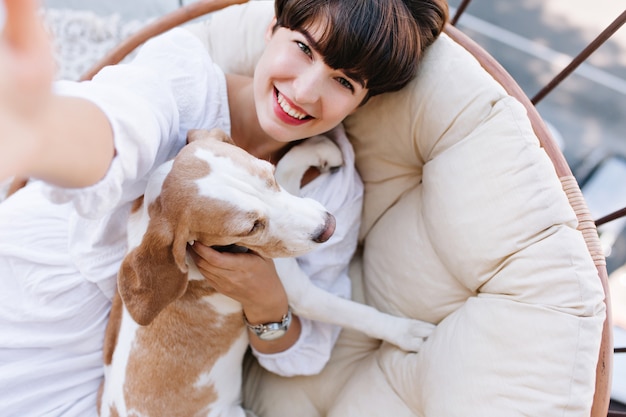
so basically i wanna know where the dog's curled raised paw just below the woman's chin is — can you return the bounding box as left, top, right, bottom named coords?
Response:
left=290, top=135, right=343, bottom=172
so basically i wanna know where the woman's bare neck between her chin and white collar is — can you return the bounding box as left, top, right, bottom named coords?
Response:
left=226, top=74, right=289, bottom=163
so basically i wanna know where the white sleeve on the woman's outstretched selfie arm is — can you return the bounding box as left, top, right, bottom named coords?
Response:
left=43, top=28, right=230, bottom=218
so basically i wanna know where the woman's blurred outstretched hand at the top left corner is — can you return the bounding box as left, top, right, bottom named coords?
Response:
left=0, top=0, right=55, bottom=180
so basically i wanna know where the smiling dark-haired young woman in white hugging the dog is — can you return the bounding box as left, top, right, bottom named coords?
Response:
left=0, top=0, right=447, bottom=416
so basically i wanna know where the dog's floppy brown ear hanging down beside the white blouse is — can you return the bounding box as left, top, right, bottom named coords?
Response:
left=118, top=199, right=188, bottom=326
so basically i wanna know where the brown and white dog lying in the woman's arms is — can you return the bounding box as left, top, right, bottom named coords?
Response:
left=99, top=130, right=432, bottom=417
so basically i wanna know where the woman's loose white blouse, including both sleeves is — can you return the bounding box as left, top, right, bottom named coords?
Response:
left=0, top=29, right=363, bottom=417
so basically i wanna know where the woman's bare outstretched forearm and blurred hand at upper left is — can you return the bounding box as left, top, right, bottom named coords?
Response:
left=0, top=0, right=114, bottom=187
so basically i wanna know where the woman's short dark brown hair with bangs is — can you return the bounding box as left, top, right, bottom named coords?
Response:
left=275, top=0, right=448, bottom=99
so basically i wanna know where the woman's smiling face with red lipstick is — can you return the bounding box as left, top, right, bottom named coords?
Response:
left=254, top=19, right=367, bottom=142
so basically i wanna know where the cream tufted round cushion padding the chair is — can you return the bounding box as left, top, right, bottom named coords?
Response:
left=185, top=1, right=605, bottom=417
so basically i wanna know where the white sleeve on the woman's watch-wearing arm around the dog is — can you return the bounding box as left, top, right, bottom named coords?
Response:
left=253, top=126, right=363, bottom=376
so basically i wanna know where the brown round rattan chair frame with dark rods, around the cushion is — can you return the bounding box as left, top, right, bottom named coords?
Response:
left=9, top=0, right=626, bottom=417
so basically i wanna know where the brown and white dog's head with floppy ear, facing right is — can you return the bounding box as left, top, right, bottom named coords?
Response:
left=118, top=130, right=335, bottom=325
